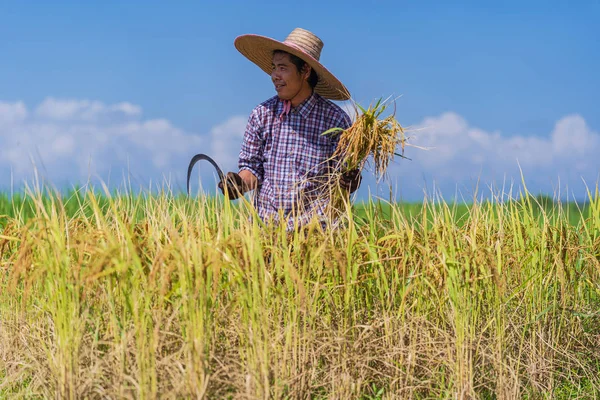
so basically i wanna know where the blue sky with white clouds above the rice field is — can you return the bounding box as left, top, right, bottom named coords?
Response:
left=0, top=0, right=600, bottom=200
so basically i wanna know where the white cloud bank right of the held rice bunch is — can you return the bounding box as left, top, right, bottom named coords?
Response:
left=390, top=112, right=600, bottom=199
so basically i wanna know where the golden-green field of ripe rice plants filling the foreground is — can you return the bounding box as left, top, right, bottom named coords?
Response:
left=0, top=189, right=600, bottom=399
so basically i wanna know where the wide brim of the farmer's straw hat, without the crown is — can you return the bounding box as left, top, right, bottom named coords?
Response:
left=234, top=35, right=350, bottom=100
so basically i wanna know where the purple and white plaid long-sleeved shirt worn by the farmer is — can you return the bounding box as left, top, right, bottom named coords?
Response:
left=239, top=93, right=351, bottom=229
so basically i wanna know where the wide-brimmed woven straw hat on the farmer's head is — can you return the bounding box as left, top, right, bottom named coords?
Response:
left=234, top=28, right=350, bottom=100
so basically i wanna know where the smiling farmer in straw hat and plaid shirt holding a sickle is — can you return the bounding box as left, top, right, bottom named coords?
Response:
left=219, top=28, right=361, bottom=230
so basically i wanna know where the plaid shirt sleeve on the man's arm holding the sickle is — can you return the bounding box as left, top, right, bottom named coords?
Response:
left=238, top=110, right=265, bottom=184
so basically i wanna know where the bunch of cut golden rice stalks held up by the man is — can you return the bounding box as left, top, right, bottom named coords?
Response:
left=323, top=99, right=406, bottom=178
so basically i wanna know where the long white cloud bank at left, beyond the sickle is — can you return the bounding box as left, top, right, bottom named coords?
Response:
left=0, top=98, right=211, bottom=187
